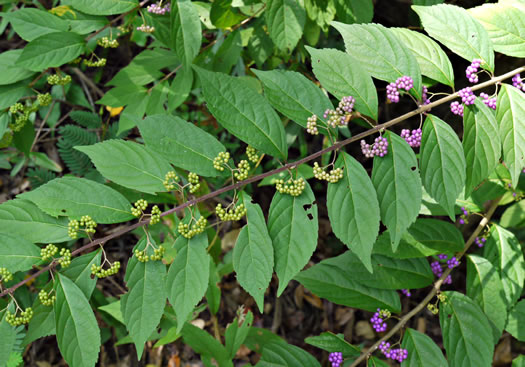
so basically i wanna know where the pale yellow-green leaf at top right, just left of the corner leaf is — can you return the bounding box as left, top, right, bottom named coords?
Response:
left=412, top=4, right=494, bottom=71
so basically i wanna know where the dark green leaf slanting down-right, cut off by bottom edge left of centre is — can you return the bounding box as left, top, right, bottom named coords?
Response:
left=182, top=323, right=233, bottom=367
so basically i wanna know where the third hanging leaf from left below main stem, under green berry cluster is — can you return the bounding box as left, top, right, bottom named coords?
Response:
left=166, top=233, right=210, bottom=332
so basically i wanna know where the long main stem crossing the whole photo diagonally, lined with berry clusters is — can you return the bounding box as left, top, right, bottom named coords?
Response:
left=0, top=66, right=525, bottom=298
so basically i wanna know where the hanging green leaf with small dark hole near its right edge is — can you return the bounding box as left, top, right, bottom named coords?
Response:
left=372, top=132, right=422, bottom=251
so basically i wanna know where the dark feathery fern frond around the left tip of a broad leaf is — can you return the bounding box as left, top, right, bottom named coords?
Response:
left=57, top=125, right=97, bottom=176
